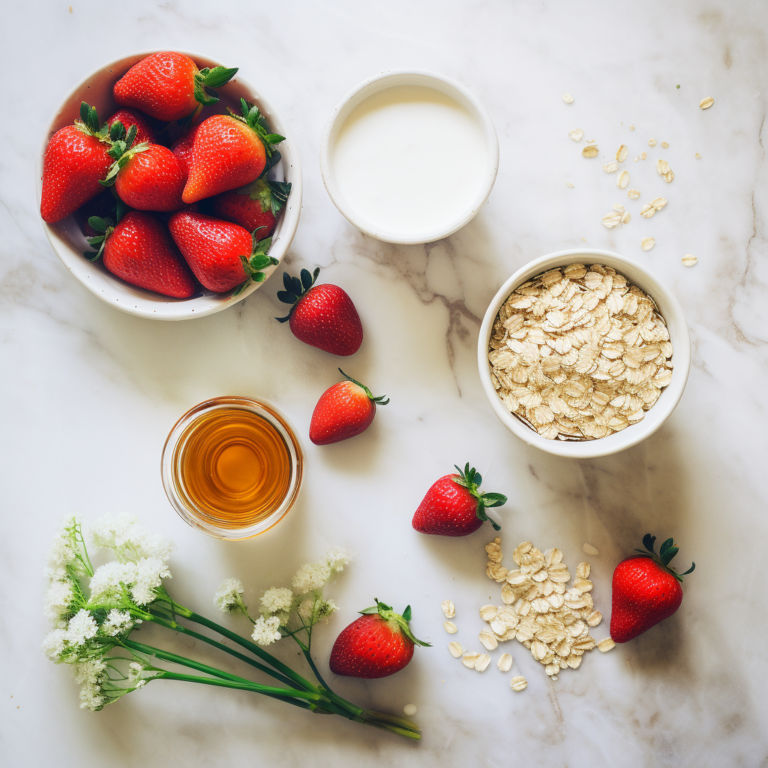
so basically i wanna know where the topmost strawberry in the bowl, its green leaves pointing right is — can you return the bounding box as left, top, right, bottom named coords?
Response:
left=113, top=51, right=237, bottom=121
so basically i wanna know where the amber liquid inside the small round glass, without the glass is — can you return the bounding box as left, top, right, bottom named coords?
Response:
left=176, top=407, right=292, bottom=528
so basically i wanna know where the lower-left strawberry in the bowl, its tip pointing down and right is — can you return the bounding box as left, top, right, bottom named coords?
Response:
left=85, top=211, right=195, bottom=299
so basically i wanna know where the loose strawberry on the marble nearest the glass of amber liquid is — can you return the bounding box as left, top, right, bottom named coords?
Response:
left=309, top=368, right=389, bottom=445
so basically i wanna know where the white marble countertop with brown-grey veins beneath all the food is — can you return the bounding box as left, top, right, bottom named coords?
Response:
left=0, top=0, right=768, bottom=768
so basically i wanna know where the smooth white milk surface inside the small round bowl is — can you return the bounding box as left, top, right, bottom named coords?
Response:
left=333, top=85, right=488, bottom=239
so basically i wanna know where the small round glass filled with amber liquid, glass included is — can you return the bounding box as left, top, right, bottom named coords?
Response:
left=162, top=397, right=304, bottom=540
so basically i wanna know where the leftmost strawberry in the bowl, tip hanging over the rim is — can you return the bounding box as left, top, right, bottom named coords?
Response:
left=40, top=102, right=112, bottom=224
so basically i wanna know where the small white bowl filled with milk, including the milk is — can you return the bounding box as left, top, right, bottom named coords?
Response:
left=320, top=71, right=499, bottom=244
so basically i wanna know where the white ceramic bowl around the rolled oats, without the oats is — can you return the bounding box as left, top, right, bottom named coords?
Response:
left=477, top=249, right=691, bottom=459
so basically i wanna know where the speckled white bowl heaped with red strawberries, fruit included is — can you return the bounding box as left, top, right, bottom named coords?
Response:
left=37, top=51, right=302, bottom=320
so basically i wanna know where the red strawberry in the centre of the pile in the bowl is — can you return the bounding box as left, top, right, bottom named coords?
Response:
left=108, top=144, right=184, bottom=211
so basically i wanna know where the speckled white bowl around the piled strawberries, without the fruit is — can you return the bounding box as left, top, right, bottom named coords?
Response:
left=36, top=49, right=302, bottom=320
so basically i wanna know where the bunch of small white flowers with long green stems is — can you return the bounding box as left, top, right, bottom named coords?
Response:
left=43, top=515, right=421, bottom=740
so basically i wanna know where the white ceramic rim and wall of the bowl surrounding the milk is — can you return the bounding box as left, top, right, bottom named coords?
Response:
left=320, top=70, right=499, bottom=244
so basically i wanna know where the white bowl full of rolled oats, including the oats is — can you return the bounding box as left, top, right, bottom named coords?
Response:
left=478, top=249, right=691, bottom=459
